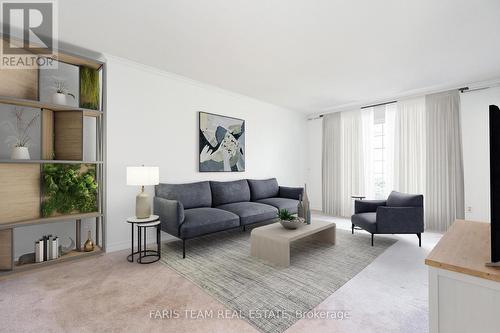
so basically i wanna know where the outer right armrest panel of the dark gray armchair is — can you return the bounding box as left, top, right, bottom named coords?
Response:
left=377, top=207, right=424, bottom=234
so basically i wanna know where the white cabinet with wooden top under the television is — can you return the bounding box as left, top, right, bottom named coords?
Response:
left=425, top=220, right=500, bottom=333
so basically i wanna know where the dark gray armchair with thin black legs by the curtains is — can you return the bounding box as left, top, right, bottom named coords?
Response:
left=351, top=191, right=424, bottom=247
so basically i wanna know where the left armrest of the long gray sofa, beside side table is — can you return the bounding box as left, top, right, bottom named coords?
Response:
left=153, top=197, right=184, bottom=237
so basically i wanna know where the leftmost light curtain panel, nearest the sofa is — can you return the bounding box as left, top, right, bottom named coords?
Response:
left=322, top=110, right=370, bottom=217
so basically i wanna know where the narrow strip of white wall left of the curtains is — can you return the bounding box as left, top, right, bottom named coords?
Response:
left=306, top=118, right=323, bottom=210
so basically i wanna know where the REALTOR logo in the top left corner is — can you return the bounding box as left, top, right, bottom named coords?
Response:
left=0, top=0, right=57, bottom=68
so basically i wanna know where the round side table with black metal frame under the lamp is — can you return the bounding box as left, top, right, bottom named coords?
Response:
left=127, top=215, right=161, bottom=264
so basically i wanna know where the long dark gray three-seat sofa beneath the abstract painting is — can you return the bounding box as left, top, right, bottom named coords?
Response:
left=153, top=178, right=303, bottom=258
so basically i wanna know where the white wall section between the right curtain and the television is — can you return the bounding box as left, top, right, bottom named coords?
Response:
left=460, top=87, right=500, bottom=222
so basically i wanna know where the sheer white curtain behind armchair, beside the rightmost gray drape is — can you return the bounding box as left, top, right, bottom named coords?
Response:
left=393, top=97, right=426, bottom=194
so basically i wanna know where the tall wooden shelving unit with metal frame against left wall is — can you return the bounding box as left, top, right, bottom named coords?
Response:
left=0, top=35, right=106, bottom=275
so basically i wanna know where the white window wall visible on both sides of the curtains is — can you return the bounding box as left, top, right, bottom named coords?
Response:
left=307, top=87, right=500, bottom=222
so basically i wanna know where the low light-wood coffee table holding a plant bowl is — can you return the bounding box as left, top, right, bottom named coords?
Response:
left=250, top=221, right=335, bottom=266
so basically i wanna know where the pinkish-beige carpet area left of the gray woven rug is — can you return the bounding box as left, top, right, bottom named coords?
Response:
left=0, top=251, right=256, bottom=333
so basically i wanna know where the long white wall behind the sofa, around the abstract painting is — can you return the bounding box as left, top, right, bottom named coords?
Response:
left=106, top=56, right=307, bottom=251
